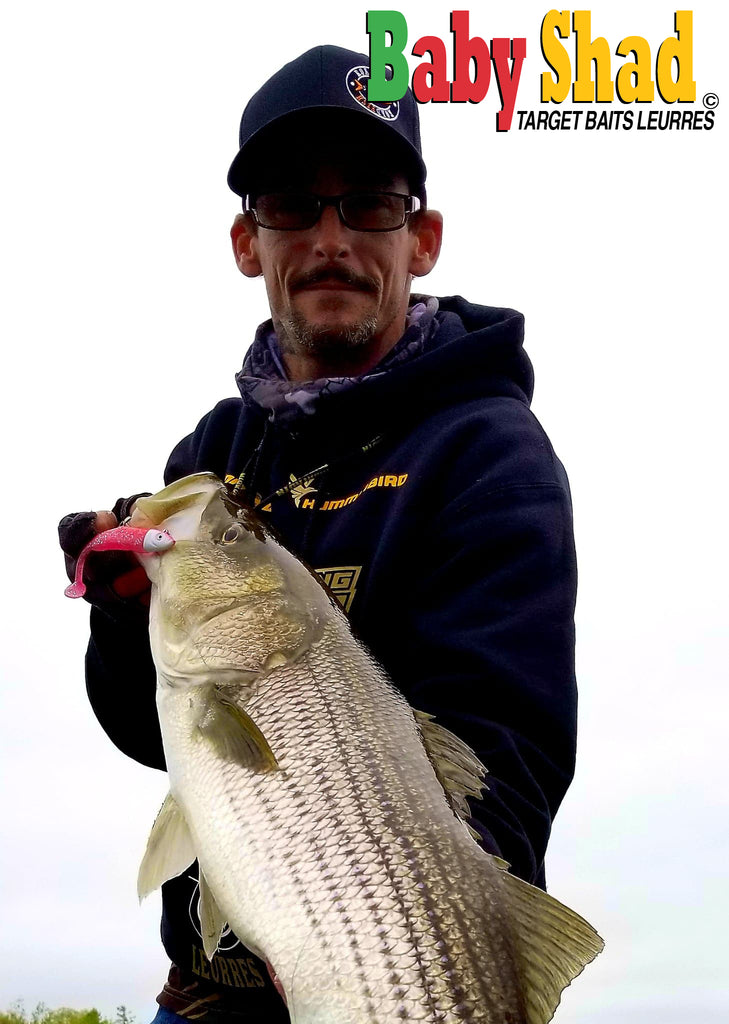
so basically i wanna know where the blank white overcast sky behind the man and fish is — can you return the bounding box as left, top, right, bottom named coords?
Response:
left=0, top=0, right=729, bottom=1024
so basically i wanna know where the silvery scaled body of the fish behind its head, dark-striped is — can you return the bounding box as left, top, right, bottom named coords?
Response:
left=159, top=628, right=524, bottom=1024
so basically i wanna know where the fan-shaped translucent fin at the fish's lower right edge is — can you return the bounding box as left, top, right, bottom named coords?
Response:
left=491, top=858, right=605, bottom=1024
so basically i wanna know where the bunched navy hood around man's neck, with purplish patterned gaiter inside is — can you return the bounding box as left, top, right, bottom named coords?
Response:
left=235, top=296, right=533, bottom=434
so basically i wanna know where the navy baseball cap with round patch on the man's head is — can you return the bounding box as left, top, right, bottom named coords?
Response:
left=227, top=46, right=426, bottom=205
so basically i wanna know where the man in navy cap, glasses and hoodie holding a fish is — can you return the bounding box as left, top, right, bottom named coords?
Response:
left=60, top=46, right=575, bottom=1021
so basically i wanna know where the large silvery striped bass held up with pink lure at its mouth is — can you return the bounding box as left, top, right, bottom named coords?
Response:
left=132, top=473, right=602, bottom=1024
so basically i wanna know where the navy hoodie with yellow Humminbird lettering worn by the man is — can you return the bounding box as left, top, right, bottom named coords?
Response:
left=87, top=296, right=576, bottom=1007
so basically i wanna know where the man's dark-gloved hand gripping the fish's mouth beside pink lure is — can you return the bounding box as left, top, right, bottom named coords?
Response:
left=58, top=495, right=155, bottom=615
